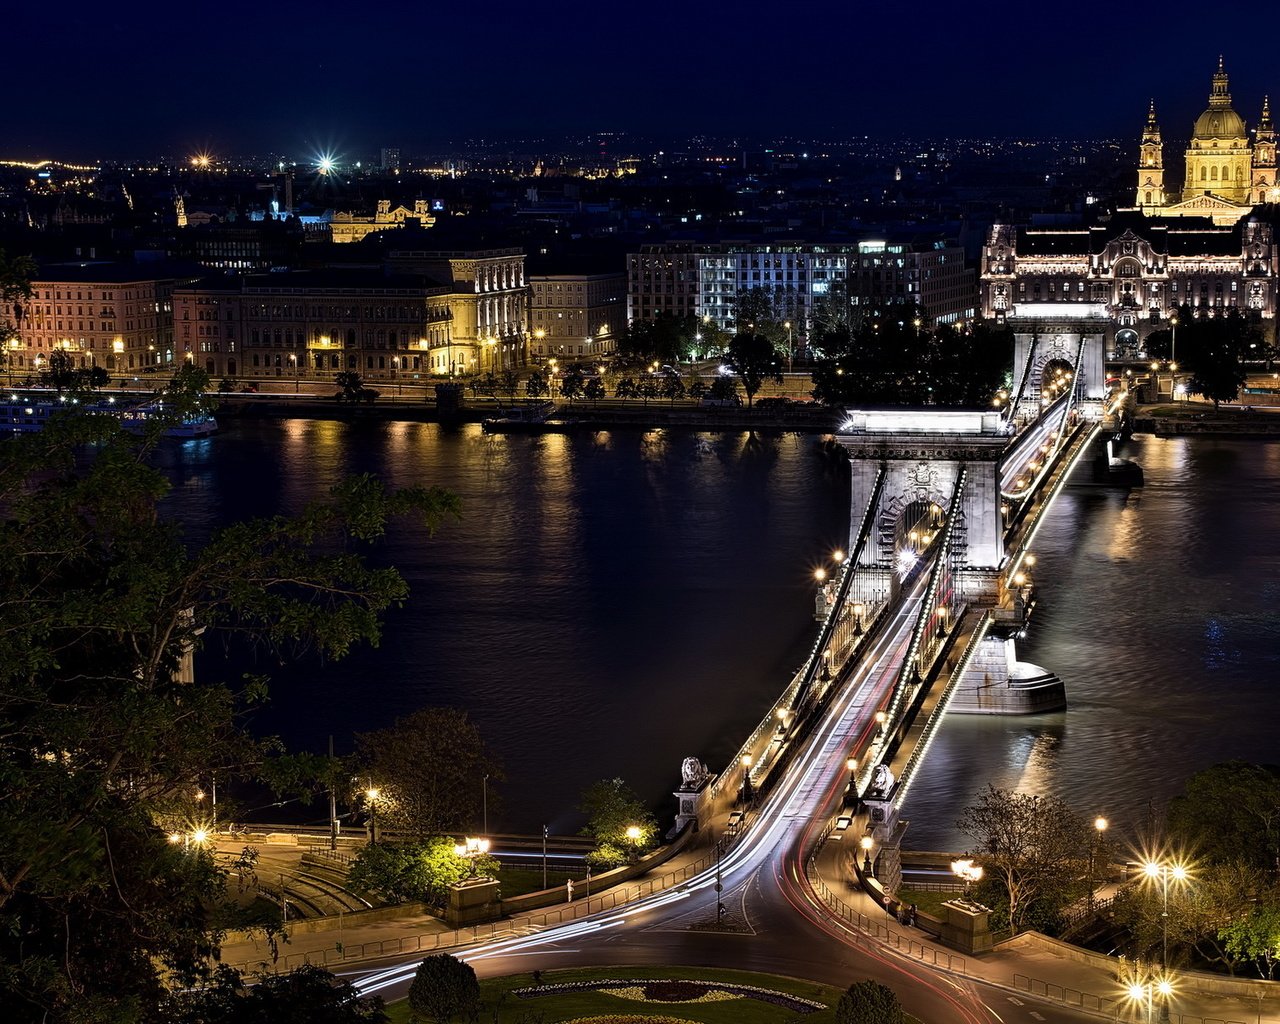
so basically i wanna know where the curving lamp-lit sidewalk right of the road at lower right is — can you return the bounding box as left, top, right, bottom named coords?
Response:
left=808, top=819, right=1280, bottom=1024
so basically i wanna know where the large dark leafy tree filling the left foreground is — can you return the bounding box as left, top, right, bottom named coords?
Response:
left=0, top=417, right=458, bottom=1024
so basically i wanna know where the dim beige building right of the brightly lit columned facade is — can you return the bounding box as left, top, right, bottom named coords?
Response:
left=529, top=274, right=627, bottom=362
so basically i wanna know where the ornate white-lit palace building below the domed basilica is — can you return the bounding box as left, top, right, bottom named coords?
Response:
left=980, top=211, right=1280, bottom=358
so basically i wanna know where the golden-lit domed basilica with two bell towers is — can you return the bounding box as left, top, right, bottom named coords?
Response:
left=1137, top=58, right=1280, bottom=224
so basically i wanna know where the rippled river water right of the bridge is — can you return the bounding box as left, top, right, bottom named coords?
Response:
left=904, top=438, right=1280, bottom=849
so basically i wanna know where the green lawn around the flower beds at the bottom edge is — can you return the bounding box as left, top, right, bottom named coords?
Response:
left=387, top=966, right=841, bottom=1024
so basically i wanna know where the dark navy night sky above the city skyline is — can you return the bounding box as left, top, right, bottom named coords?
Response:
left=0, top=0, right=1280, bottom=159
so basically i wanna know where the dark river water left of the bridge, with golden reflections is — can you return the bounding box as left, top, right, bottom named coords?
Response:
left=166, top=421, right=849, bottom=829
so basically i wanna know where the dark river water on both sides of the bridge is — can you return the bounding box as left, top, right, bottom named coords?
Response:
left=163, top=420, right=1280, bottom=849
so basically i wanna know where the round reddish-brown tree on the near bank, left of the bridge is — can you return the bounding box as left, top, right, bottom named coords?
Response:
left=356, top=708, right=503, bottom=838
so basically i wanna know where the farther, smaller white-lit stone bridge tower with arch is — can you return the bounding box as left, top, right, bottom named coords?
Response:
left=1005, top=303, right=1111, bottom=422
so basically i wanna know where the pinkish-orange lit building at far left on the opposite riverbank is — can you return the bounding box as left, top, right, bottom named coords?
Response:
left=5, top=262, right=191, bottom=375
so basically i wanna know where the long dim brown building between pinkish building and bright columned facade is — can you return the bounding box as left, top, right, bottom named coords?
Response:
left=174, top=270, right=452, bottom=381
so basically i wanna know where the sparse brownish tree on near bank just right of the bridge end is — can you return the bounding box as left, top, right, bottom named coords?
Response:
left=956, top=786, right=1093, bottom=934
